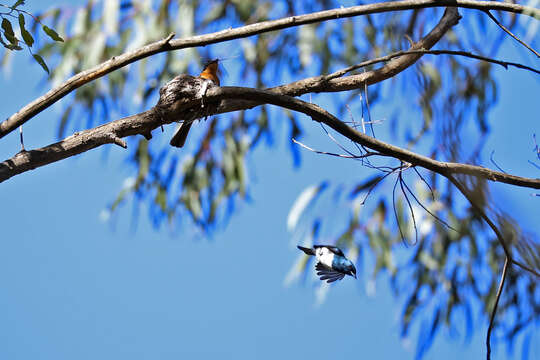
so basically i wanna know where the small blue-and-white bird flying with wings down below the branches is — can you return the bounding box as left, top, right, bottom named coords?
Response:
left=298, top=245, right=356, bottom=283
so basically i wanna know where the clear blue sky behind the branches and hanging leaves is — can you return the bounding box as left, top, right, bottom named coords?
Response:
left=0, top=1, right=540, bottom=360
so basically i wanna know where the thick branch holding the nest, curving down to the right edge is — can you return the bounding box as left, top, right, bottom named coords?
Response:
left=0, top=87, right=540, bottom=189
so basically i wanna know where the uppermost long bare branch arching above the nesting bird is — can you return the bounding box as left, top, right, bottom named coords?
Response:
left=0, top=0, right=540, bottom=138
